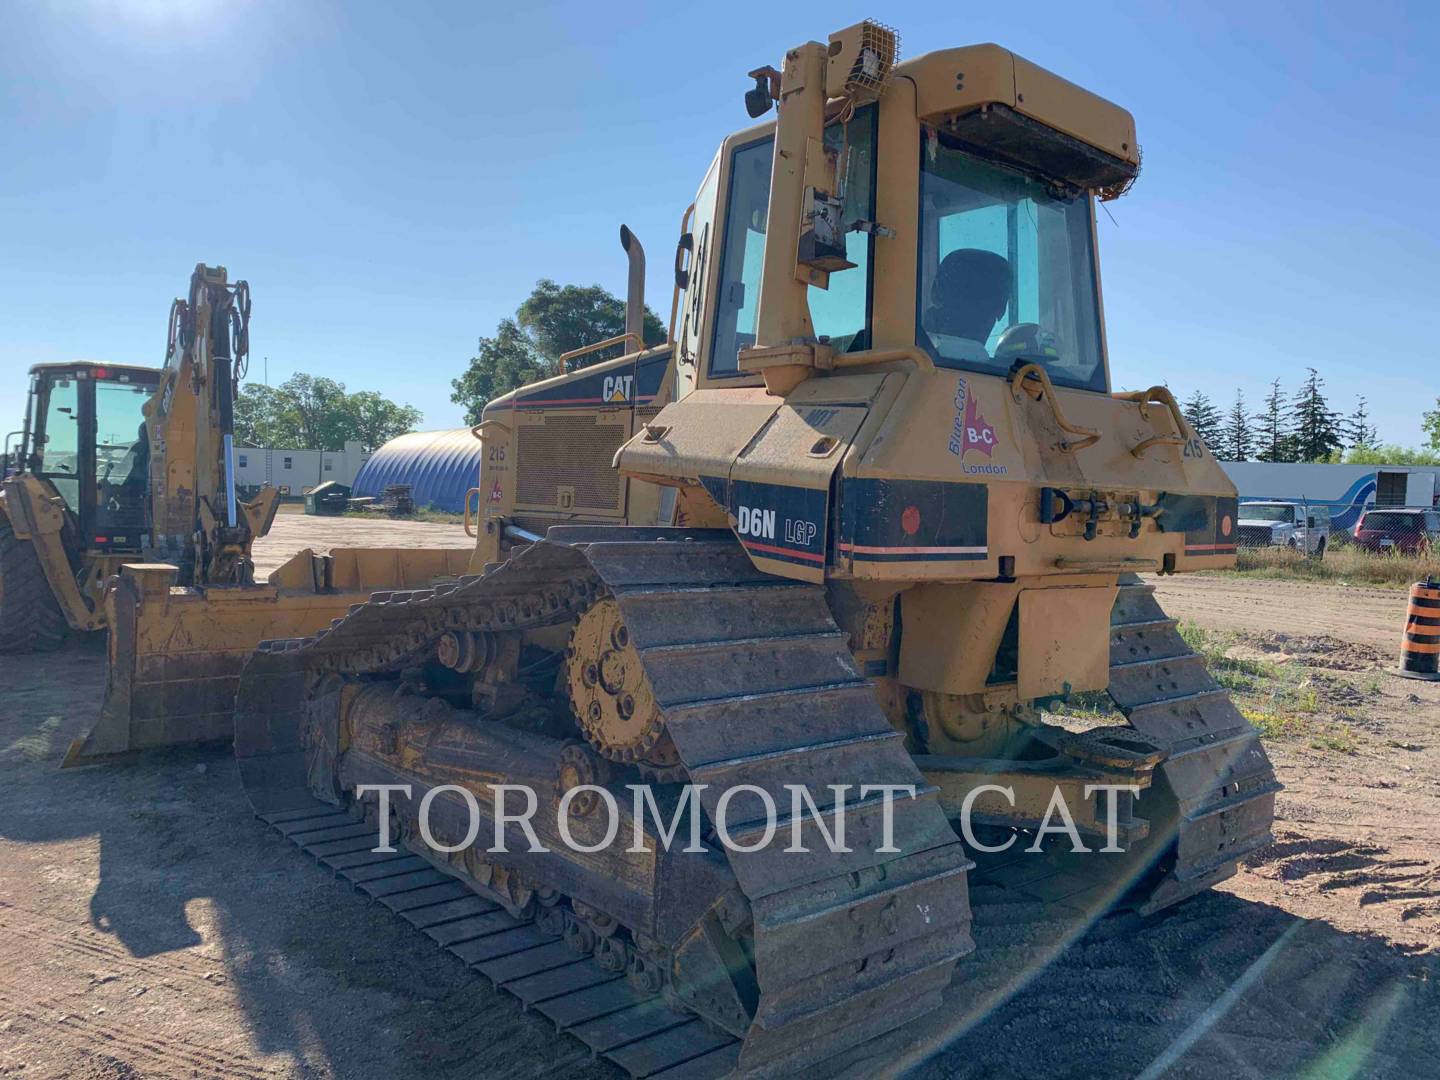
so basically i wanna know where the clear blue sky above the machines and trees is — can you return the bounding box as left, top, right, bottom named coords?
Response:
left=0, top=0, right=1440, bottom=445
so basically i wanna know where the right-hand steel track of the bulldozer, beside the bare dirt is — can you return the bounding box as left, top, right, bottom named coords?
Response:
left=1110, top=575, right=1280, bottom=914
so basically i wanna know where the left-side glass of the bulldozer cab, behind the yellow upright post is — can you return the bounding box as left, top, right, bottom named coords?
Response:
left=710, top=105, right=876, bottom=377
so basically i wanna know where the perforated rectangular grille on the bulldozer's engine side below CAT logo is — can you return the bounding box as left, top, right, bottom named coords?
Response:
left=516, top=416, right=628, bottom=513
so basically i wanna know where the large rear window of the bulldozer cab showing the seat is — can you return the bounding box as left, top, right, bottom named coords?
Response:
left=916, top=128, right=1107, bottom=390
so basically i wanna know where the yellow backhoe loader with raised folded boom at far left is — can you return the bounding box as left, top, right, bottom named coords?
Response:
left=0, top=265, right=279, bottom=652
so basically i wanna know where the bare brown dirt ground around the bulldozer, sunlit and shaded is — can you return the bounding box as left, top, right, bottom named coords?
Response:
left=0, top=516, right=1440, bottom=1080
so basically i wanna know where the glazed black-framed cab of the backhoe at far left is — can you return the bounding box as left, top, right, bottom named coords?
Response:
left=22, top=363, right=160, bottom=552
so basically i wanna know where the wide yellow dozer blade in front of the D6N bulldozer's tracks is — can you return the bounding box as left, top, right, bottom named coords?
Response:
left=62, top=549, right=469, bottom=768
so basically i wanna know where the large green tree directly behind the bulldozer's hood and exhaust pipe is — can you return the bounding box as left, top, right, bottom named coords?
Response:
left=451, top=278, right=665, bottom=423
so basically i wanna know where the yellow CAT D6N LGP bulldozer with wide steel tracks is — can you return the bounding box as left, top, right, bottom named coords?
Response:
left=235, top=22, right=1279, bottom=1079
